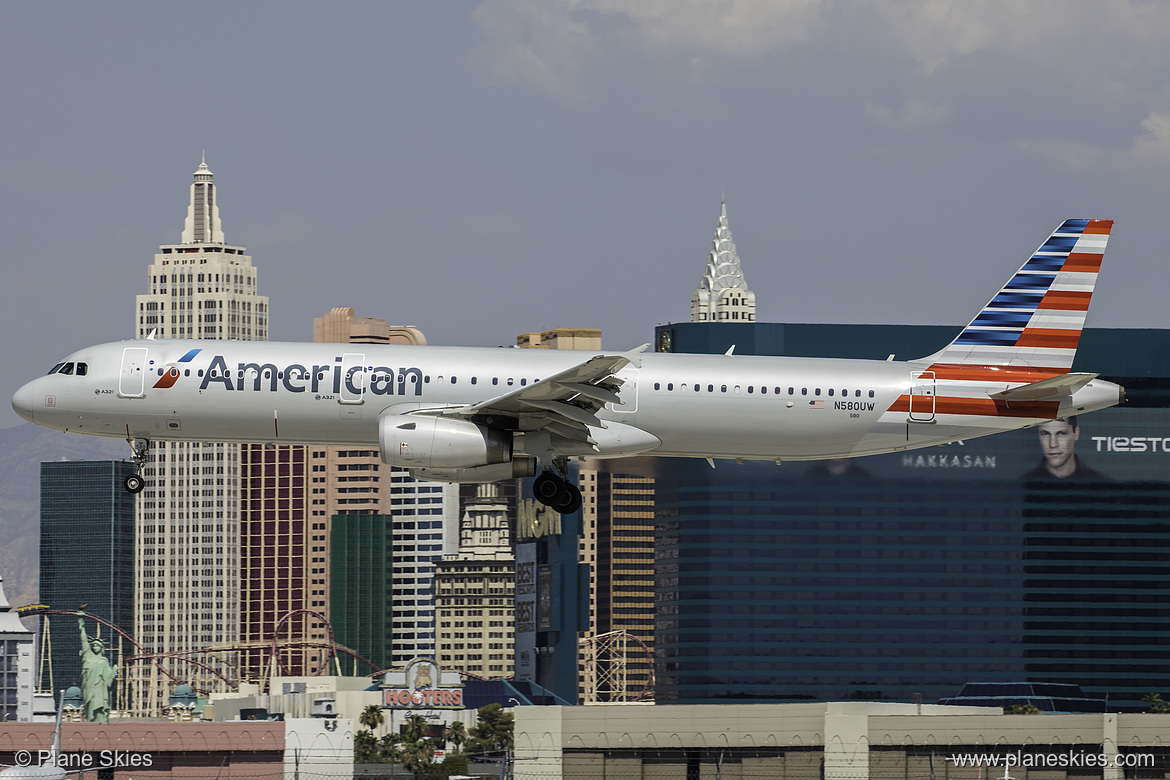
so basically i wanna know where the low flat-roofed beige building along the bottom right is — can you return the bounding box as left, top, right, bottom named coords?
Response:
left=515, top=702, right=1170, bottom=780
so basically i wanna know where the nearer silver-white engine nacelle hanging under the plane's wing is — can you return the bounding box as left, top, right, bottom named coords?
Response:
left=378, top=414, right=512, bottom=469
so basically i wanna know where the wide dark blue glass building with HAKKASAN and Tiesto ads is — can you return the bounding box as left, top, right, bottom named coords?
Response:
left=650, top=323, right=1170, bottom=710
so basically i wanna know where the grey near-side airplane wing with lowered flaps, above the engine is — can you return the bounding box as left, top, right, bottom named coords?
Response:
left=430, top=344, right=649, bottom=449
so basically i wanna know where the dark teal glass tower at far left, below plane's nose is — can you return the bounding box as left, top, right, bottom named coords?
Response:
left=40, top=461, right=135, bottom=710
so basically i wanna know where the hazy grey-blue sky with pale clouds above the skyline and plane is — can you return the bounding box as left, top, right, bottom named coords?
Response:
left=0, top=0, right=1170, bottom=427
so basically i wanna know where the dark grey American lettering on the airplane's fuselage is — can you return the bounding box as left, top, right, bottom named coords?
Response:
left=196, top=353, right=422, bottom=395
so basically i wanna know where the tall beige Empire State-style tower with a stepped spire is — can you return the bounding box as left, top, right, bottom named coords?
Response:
left=126, top=161, right=268, bottom=716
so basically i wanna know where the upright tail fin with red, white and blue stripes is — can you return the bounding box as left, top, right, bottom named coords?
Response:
left=927, top=220, right=1113, bottom=375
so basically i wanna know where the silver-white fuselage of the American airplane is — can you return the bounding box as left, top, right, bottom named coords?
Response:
left=13, top=339, right=1123, bottom=461
